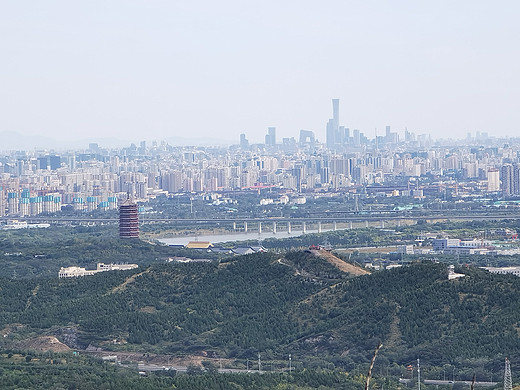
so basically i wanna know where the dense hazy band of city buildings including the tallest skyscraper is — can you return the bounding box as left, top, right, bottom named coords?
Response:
left=0, top=99, right=520, bottom=217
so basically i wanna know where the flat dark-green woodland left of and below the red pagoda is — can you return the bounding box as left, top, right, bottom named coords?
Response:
left=0, top=226, right=219, bottom=279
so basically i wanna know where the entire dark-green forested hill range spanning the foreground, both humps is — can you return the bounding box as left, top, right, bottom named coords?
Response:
left=0, top=252, right=520, bottom=367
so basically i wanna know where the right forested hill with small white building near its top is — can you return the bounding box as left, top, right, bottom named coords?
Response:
left=294, top=263, right=520, bottom=365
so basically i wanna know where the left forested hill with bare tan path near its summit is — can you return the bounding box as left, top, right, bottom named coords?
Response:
left=0, top=254, right=343, bottom=354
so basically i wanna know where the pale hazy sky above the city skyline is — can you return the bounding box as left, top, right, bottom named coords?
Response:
left=0, top=0, right=520, bottom=143
